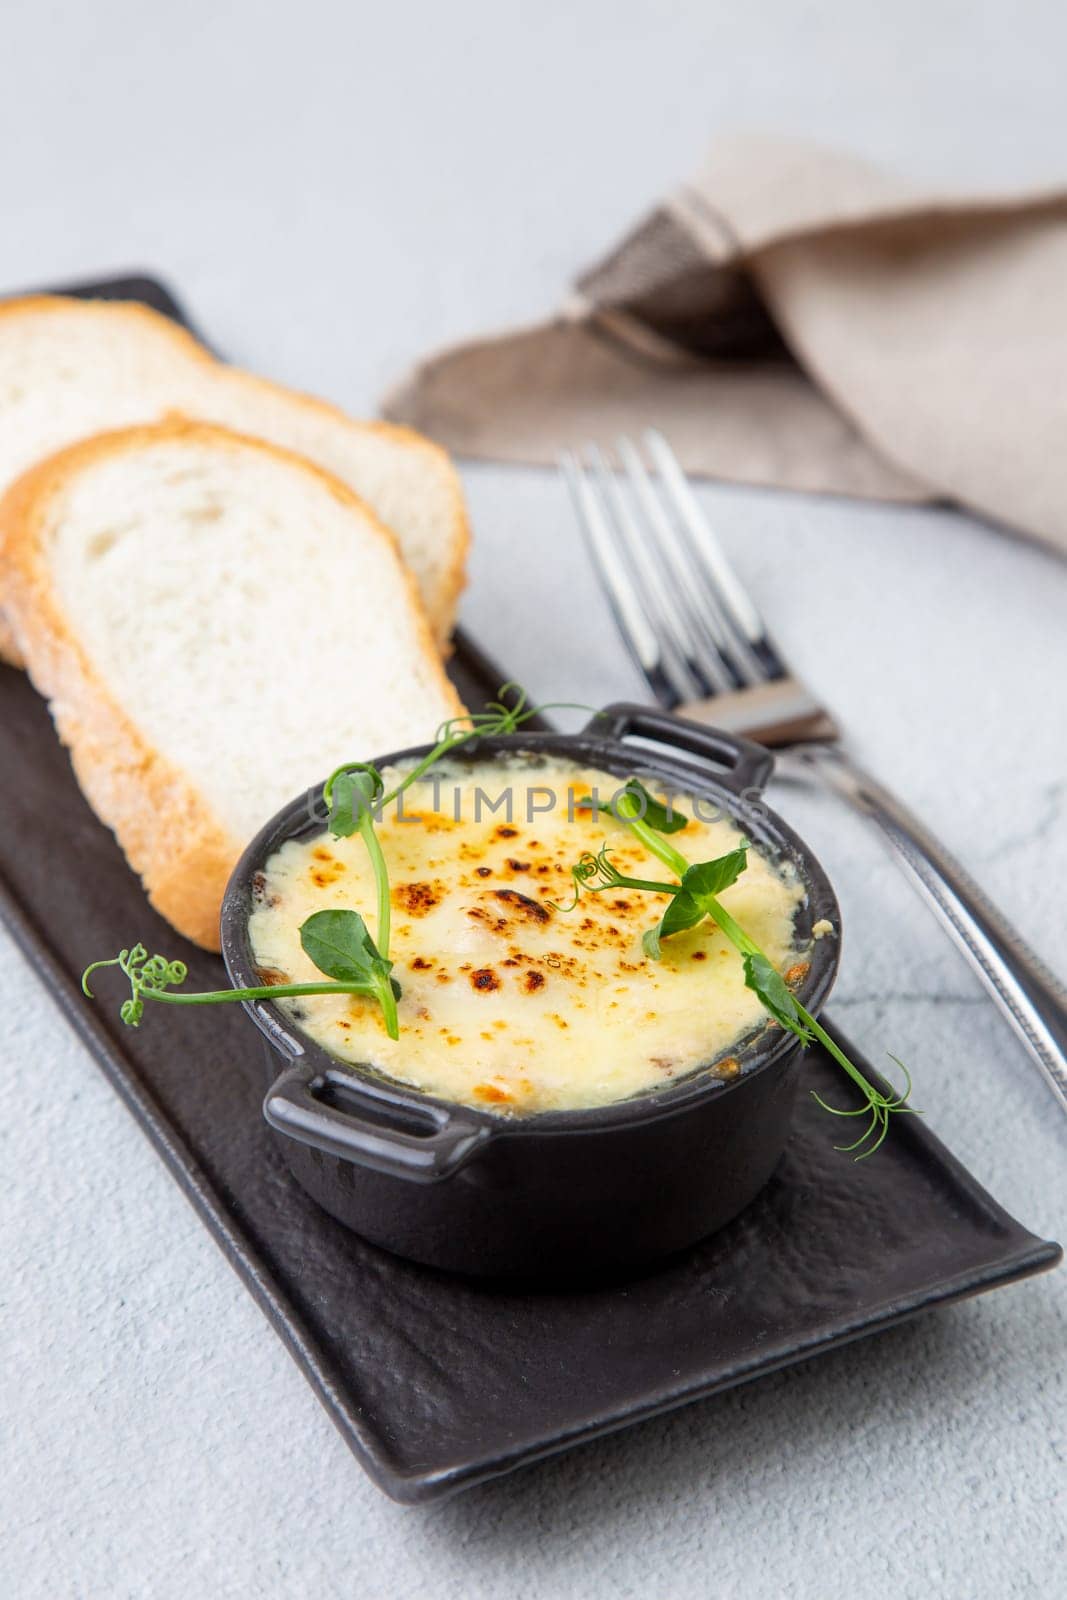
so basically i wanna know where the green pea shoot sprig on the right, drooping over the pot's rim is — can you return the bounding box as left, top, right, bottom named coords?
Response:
left=560, top=779, right=915, bottom=1160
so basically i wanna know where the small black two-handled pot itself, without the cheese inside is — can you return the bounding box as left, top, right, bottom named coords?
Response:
left=222, top=706, right=840, bottom=1280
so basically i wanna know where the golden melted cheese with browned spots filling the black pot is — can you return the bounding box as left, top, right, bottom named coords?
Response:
left=250, top=757, right=803, bottom=1115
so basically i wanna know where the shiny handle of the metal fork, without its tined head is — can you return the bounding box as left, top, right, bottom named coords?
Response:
left=796, top=744, right=1067, bottom=1110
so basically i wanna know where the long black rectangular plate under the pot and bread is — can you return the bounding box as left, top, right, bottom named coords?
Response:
left=0, top=278, right=1061, bottom=1501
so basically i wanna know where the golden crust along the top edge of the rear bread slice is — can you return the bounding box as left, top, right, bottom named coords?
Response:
left=0, top=294, right=470, bottom=649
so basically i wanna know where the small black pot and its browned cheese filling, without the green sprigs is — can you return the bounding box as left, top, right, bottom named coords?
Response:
left=211, top=706, right=838, bottom=1277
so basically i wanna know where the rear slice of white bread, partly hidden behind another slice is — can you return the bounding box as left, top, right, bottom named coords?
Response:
left=0, top=294, right=469, bottom=664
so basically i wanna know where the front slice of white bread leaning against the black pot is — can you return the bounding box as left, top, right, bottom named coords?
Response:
left=0, top=422, right=462, bottom=949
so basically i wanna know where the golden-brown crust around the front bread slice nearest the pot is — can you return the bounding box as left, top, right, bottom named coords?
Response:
left=0, top=419, right=464, bottom=950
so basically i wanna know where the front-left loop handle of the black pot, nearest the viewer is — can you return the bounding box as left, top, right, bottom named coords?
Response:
left=262, top=1067, right=493, bottom=1184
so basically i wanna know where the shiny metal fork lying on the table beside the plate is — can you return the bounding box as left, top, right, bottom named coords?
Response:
left=560, top=430, right=1067, bottom=1110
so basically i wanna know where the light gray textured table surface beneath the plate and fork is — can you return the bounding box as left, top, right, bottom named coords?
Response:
left=0, top=0, right=1067, bottom=1600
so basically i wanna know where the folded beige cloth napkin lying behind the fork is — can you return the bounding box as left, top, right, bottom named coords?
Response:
left=384, top=136, right=1067, bottom=549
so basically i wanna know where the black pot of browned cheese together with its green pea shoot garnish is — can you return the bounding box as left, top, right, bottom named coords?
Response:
left=82, top=691, right=934, bottom=1278
